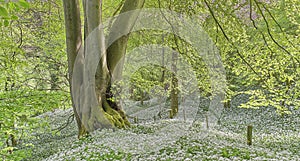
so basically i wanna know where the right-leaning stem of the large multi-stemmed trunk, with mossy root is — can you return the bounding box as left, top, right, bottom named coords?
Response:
left=97, top=0, right=145, bottom=127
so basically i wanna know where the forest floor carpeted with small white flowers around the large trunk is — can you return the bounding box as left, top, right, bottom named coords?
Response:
left=20, top=96, right=300, bottom=161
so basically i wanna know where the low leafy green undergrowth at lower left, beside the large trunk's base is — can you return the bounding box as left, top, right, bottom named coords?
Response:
left=0, top=90, right=68, bottom=157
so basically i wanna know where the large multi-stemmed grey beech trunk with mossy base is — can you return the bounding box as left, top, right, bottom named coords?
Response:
left=63, top=0, right=144, bottom=137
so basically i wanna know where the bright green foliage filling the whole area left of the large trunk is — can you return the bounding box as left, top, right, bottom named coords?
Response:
left=0, top=0, right=70, bottom=160
